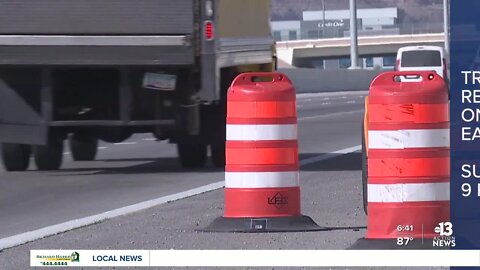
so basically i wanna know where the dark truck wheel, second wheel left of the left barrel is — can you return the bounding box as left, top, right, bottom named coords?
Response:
left=177, top=140, right=207, bottom=168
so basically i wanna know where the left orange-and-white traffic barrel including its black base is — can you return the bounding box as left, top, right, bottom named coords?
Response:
left=202, top=73, right=319, bottom=232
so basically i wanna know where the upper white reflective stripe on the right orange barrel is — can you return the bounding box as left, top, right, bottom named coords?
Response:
left=368, top=129, right=450, bottom=149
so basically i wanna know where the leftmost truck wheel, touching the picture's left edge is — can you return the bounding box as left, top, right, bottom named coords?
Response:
left=2, top=143, right=32, bottom=172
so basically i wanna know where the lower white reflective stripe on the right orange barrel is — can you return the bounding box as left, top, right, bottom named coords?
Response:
left=367, top=182, right=450, bottom=203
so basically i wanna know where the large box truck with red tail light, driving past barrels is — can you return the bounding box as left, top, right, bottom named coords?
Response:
left=0, top=0, right=275, bottom=171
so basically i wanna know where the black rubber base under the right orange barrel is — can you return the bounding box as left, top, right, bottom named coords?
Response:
left=348, top=238, right=449, bottom=250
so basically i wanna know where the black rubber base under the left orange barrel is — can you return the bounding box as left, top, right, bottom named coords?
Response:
left=198, top=215, right=326, bottom=233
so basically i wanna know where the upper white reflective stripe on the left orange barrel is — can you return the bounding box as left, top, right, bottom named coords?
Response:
left=227, top=124, right=298, bottom=141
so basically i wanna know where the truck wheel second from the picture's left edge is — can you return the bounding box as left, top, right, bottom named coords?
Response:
left=33, top=138, right=63, bottom=171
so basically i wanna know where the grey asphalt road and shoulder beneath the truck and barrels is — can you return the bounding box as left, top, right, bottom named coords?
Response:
left=0, top=92, right=424, bottom=269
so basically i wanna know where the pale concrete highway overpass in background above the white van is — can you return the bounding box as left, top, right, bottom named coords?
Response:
left=276, top=33, right=444, bottom=66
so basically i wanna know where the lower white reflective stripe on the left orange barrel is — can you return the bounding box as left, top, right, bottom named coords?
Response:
left=225, top=171, right=300, bottom=188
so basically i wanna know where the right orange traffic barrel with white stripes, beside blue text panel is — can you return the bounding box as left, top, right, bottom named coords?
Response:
left=356, top=72, right=450, bottom=248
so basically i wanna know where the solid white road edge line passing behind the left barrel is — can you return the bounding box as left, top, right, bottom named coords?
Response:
left=0, top=145, right=361, bottom=250
